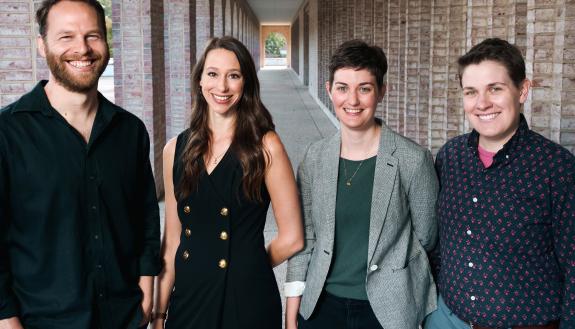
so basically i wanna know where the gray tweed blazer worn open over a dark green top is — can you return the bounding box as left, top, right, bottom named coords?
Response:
left=286, top=124, right=438, bottom=329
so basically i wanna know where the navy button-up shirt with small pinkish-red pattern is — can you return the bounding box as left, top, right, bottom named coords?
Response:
left=435, top=115, right=575, bottom=329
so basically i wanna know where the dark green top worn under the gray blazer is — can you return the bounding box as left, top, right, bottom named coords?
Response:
left=325, top=157, right=377, bottom=300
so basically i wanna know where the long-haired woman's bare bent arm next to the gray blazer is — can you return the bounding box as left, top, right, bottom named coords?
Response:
left=264, top=132, right=303, bottom=266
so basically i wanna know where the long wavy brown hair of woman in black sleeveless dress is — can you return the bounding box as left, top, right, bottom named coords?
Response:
left=175, top=36, right=275, bottom=202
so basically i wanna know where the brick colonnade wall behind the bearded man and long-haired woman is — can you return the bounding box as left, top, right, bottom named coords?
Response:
left=0, top=0, right=260, bottom=194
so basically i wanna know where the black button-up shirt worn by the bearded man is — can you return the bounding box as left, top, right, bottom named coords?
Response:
left=0, top=81, right=161, bottom=329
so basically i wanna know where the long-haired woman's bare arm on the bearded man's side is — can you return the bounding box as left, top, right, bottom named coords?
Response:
left=153, top=138, right=182, bottom=328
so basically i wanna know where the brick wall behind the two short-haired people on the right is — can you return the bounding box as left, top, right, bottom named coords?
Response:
left=294, top=0, right=575, bottom=153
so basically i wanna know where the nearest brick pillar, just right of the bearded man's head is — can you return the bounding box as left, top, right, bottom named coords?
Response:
left=112, top=0, right=166, bottom=195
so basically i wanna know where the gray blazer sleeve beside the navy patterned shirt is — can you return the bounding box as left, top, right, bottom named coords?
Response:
left=408, top=150, right=439, bottom=252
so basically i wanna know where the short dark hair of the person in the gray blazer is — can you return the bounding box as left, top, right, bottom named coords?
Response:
left=329, top=39, right=387, bottom=89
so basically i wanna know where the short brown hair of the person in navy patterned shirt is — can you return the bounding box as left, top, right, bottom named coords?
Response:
left=457, top=38, right=526, bottom=88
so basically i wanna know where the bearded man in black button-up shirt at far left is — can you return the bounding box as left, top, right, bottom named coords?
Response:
left=0, top=0, right=161, bottom=329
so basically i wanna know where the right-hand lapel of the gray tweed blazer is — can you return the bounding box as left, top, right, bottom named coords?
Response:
left=368, top=124, right=398, bottom=262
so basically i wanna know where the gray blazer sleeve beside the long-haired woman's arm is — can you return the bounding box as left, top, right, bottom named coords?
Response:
left=286, top=148, right=316, bottom=282
